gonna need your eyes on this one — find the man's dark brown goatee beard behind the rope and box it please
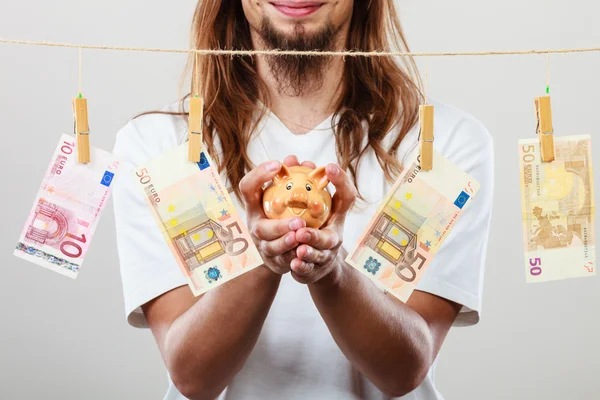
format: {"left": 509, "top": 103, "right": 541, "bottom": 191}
{"left": 261, "top": 18, "right": 335, "bottom": 96}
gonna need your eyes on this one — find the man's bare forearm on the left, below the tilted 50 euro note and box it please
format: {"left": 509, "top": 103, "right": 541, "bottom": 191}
{"left": 165, "top": 266, "right": 281, "bottom": 400}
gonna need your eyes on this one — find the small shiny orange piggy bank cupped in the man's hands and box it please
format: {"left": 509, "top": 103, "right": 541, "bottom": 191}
{"left": 263, "top": 165, "right": 331, "bottom": 229}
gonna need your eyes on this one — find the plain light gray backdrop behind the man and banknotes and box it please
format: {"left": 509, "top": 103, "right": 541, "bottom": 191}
{"left": 0, "top": 0, "right": 600, "bottom": 400}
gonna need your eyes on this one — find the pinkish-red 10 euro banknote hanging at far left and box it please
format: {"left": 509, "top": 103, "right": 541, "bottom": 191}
{"left": 13, "top": 134, "right": 119, "bottom": 278}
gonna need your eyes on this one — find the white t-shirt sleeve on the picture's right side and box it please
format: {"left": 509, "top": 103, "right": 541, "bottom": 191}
{"left": 417, "top": 116, "right": 494, "bottom": 326}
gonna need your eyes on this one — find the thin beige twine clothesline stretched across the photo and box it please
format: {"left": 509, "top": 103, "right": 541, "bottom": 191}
{"left": 0, "top": 39, "right": 600, "bottom": 57}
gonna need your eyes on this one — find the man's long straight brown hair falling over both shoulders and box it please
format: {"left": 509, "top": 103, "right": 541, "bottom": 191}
{"left": 162, "top": 0, "right": 422, "bottom": 198}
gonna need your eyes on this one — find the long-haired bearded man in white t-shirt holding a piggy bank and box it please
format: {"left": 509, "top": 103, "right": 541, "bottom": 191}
{"left": 114, "top": 0, "right": 493, "bottom": 400}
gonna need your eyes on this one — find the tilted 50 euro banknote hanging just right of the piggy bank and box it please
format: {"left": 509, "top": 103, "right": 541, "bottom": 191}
{"left": 346, "top": 152, "right": 480, "bottom": 302}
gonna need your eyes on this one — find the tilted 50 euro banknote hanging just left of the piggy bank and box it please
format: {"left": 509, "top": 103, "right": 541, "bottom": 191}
{"left": 132, "top": 143, "right": 263, "bottom": 296}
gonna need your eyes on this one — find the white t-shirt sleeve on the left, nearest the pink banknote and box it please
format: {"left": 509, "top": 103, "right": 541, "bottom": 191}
{"left": 113, "top": 117, "right": 186, "bottom": 328}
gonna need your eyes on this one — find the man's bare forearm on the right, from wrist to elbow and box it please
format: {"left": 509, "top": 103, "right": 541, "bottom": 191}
{"left": 309, "top": 252, "right": 435, "bottom": 397}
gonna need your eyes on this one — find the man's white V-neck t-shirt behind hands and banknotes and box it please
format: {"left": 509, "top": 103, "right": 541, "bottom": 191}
{"left": 113, "top": 97, "right": 494, "bottom": 400}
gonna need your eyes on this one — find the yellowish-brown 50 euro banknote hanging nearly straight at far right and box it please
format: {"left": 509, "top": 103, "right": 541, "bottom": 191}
{"left": 519, "top": 135, "right": 596, "bottom": 283}
